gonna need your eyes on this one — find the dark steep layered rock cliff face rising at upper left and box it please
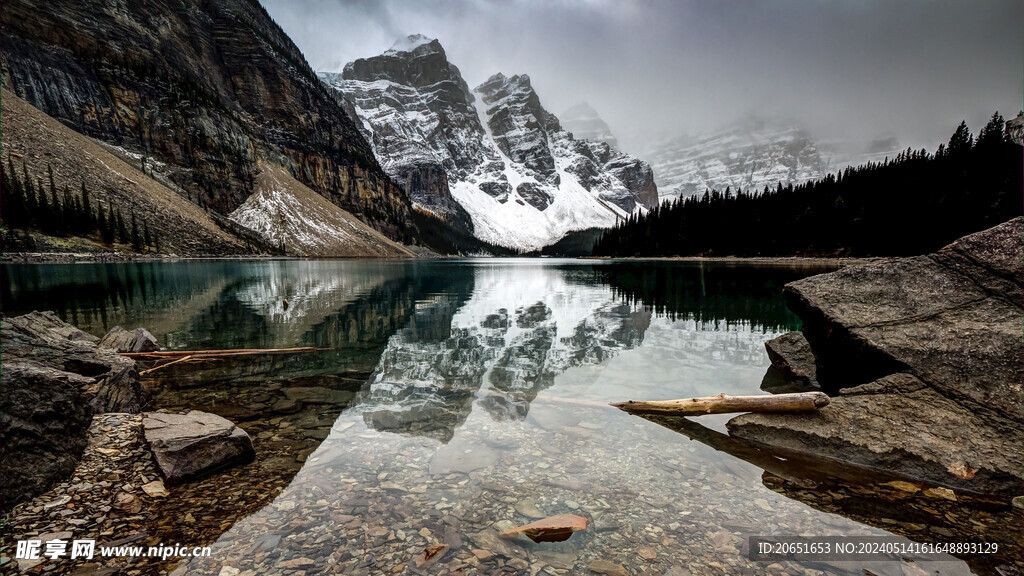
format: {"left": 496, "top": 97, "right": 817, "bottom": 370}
{"left": 0, "top": 0, "right": 409, "bottom": 237}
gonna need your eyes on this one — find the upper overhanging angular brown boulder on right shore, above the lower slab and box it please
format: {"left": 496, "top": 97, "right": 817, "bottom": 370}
{"left": 783, "top": 218, "right": 1024, "bottom": 412}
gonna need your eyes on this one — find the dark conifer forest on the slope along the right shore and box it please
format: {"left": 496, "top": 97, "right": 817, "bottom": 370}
{"left": 593, "top": 113, "right": 1024, "bottom": 256}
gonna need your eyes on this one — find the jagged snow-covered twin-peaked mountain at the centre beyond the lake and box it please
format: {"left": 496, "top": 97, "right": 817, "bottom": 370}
{"left": 321, "top": 35, "right": 657, "bottom": 249}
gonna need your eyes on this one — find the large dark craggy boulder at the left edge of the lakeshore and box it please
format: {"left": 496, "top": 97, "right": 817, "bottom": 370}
{"left": 0, "top": 312, "right": 144, "bottom": 505}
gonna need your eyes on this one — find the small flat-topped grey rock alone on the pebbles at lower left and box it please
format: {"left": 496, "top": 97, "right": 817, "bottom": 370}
{"left": 142, "top": 410, "right": 255, "bottom": 485}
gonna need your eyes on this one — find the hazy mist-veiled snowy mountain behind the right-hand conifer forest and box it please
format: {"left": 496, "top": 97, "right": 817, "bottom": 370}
{"left": 644, "top": 119, "right": 899, "bottom": 200}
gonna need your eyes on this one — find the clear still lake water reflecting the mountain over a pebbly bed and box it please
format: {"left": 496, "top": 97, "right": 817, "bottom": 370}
{"left": 2, "top": 259, "right": 1021, "bottom": 576}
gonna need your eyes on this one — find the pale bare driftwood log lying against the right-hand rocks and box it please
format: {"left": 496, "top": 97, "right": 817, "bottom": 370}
{"left": 612, "top": 392, "right": 828, "bottom": 416}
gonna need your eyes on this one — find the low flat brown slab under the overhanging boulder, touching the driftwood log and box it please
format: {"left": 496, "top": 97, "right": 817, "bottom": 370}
{"left": 727, "top": 374, "right": 1024, "bottom": 494}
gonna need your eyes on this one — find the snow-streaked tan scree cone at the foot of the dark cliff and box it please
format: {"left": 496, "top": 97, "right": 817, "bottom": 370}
{"left": 228, "top": 162, "right": 412, "bottom": 257}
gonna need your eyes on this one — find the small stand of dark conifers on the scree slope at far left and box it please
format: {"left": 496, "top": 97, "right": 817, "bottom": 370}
{"left": 0, "top": 156, "right": 160, "bottom": 252}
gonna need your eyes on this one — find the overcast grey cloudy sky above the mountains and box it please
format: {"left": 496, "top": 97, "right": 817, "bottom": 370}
{"left": 261, "top": 0, "right": 1024, "bottom": 151}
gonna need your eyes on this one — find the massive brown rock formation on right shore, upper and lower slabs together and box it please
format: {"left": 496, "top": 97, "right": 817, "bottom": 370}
{"left": 728, "top": 218, "right": 1024, "bottom": 494}
